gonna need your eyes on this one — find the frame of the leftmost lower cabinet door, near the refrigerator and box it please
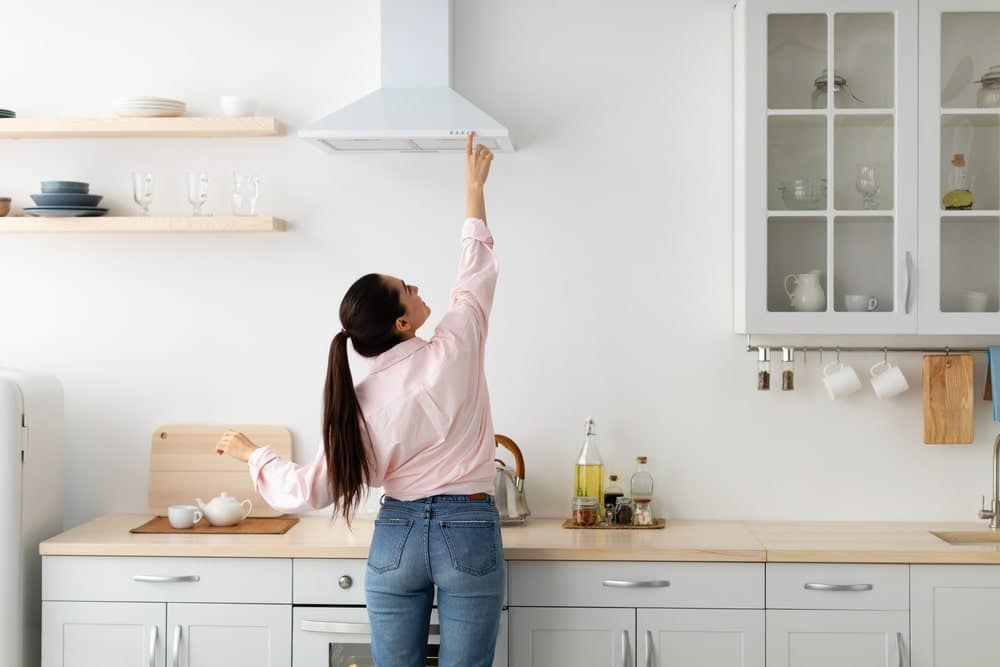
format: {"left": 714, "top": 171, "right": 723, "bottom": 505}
{"left": 41, "top": 601, "right": 167, "bottom": 667}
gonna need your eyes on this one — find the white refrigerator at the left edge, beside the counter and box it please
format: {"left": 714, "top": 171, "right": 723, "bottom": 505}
{"left": 0, "top": 369, "right": 63, "bottom": 667}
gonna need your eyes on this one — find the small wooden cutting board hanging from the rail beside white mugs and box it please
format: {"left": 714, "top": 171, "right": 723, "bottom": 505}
{"left": 923, "top": 354, "right": 973, "bottom": 445}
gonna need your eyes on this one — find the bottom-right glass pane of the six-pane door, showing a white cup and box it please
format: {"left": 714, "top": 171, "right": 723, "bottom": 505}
{"left": 833, "top": 217, "right": 896, "bottom": 312}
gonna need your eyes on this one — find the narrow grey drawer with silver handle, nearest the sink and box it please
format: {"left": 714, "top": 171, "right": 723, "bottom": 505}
{"left": 767, "top": 563, "right": 910, "bottom": 609}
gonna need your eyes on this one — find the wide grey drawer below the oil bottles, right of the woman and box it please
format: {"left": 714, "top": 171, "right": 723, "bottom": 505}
{"left": 509, "top": 561, "right": 764, "bottom": 609}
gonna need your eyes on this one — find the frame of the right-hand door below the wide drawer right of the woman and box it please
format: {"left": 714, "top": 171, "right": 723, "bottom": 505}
{"left": 635, "top": 609, "right": 765, "bottom": 667}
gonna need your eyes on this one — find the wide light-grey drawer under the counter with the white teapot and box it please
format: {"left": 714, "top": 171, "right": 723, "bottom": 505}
{"left": 42, "top": 556, "right": 292, "bottom": 604}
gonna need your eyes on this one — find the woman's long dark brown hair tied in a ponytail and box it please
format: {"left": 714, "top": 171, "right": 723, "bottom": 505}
{"left": 323, "top": 273, "right": 406, "bottom": 524}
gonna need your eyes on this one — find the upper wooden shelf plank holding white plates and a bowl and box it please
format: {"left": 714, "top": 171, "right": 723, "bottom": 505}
{"left": 0, "top": 116, "right": 285, "bottom": 139}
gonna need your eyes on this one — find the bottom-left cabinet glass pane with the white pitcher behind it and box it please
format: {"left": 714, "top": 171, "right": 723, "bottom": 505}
{"left": 767, "top": 218, "right": 826, "bottom": 312}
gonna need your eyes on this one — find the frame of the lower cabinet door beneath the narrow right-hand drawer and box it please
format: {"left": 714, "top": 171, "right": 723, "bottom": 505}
{"left": 766, "top": 609, "right": 910, "bottom": 667}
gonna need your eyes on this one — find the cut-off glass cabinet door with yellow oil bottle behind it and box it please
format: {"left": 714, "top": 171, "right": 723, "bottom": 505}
{"left": 920, "top": 0, "right": 1000, "bottom": 334}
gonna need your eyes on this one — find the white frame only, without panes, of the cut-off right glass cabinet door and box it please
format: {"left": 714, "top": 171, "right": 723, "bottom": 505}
{"left": 919, "top": 0, "right": 1000, "bottom": 335}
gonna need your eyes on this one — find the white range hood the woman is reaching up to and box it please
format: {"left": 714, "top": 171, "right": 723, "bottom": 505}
{"left": 298, "top": 0, "right": 514, "bottom": 153}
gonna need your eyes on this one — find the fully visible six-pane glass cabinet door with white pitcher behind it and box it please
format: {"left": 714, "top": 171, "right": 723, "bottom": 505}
{"left": 737, "top": 0, "right": 917, "bottom": 333}
